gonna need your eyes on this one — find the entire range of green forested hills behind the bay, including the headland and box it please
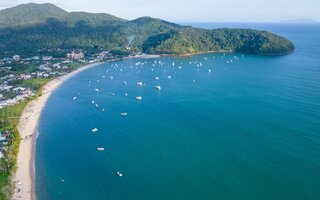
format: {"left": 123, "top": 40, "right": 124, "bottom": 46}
{"left": 0, "top": 4, "right": 294, "bottom": 56}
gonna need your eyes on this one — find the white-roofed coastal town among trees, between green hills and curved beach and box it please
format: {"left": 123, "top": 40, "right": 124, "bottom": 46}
{"left": 0, "top": 51, "right": 119, "bottom": 109}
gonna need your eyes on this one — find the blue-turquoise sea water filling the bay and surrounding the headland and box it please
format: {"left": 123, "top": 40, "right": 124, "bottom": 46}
{"left": 36, "top": 24, "right": 320, "bottom": 200}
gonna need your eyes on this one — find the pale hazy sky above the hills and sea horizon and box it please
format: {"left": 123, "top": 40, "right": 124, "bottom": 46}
{"left": 0, "top": 0, "right": 320, "bottom": 22}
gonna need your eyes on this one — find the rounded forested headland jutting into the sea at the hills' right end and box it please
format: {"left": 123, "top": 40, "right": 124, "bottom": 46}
{"left": 142, "top": 28, "right": 293, "bottom": 55}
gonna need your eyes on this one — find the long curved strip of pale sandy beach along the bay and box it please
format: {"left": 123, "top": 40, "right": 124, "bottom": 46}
{"left": 12, "top": 63, "right": 101, "bottom": 200}
